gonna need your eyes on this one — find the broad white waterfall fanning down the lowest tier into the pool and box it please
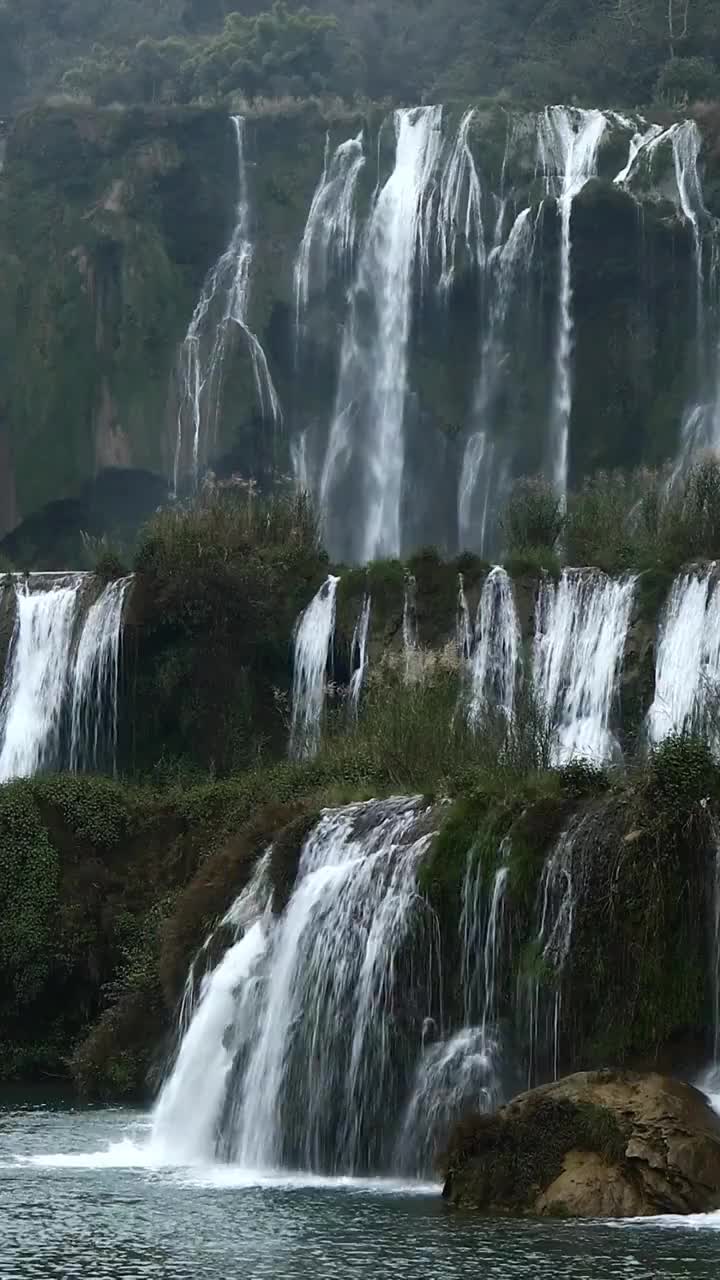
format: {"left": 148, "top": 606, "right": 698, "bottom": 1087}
{"left": 152, "top": 800, "right": 438, "bottom": 1172}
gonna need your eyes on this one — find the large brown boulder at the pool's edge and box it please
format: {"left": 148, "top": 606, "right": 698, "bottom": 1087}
{"left": 443, "top": 1071, "right": 720, "bottom": 1217}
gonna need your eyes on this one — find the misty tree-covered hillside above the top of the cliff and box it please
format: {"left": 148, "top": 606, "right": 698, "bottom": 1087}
{"left": 0, "top": 0, "right": 720, "bottom": 111}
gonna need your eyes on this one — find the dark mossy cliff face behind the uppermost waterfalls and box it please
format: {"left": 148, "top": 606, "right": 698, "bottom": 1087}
{"left": 0, "top": 104, "right": 717, "bottom": 558}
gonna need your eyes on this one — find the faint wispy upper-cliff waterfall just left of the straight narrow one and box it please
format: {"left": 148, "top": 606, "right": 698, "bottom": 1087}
{"left": 457, "top": 209, "right": 534, "bottom": 554}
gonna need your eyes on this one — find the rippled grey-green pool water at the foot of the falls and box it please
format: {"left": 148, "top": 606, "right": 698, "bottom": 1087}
{"left": 0, "top": 1102, "right": 720, "bottom": 1280}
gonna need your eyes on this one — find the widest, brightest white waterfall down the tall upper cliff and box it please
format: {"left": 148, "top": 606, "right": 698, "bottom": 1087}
{"left": 320, "top": 106, "right": 442, "bottom": 563}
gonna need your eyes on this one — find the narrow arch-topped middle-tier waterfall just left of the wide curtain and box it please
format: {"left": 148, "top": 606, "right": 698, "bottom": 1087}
{"left": 468, "top": 566, "right": 521, "bottom": 727}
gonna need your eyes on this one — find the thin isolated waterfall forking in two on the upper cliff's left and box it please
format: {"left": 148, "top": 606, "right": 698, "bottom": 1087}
{"left": 173, "top": 115, "right": 281, "bottom": 494}
